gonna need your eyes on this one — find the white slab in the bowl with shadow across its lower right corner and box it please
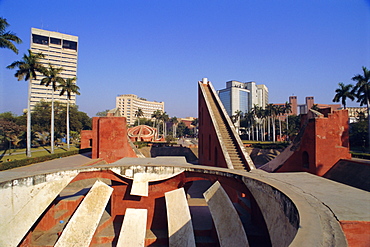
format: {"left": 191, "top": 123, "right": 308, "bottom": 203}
{"left": 165, "top": 188, "right": 195, "bottom": 247}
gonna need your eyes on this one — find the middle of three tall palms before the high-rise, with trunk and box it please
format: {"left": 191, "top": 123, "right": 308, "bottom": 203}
{"left": 40, "top": 63, "right": 64, "bottom": 154}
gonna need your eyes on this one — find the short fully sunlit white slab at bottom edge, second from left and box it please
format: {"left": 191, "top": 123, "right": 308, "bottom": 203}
{"left": 117, "top": 208, "right": 148, "bottom": 247}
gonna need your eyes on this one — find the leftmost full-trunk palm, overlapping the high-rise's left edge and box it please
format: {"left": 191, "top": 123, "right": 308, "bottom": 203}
{"left": 7, "top": 50, "right": 45, "bottom": 157}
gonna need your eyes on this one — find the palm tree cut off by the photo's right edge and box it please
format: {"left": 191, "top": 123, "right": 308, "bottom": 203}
{"left": 352, "top": 66, "right": 370, "bottom": 151}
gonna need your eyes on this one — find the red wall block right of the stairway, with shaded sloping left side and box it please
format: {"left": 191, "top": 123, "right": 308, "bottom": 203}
{"left": 278, "top": 110, "right": 351, "bottom": 176}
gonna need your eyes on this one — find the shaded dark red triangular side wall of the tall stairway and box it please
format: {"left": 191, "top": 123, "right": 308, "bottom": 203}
{"left": 198, "top": 84, "right": 227, "bottom": 168}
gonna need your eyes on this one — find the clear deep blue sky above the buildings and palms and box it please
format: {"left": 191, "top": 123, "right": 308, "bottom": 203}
{"left": 0, "top": 0, "right": 370, "bottom": 117}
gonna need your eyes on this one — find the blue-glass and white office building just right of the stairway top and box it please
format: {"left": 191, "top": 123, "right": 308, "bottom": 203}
{"left": 218, "top": 81, "right": 269, "bottom": 116}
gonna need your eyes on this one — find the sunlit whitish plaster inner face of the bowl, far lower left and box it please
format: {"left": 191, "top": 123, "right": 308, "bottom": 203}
{"left": 0, "top": 176, "right": 74, "bottom": 246}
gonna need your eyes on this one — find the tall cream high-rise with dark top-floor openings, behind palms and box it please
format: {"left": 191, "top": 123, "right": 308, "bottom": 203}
{"left": 31, "top": 28, "right": 78, "bottom": 109}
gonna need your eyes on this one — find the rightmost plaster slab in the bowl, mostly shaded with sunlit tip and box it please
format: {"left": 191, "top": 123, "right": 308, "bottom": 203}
{"left": 203, "top": 181, "right": 249, "bottom": 247}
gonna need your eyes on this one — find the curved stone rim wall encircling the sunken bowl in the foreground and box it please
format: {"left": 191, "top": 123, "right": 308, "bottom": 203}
{"left": 0, "top": 162, "right": 346, "bottom": 247}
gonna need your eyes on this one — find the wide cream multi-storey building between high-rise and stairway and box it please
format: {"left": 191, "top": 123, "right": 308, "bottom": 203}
{"left": 116, "top": 94, "right": 164, "bottom": 125}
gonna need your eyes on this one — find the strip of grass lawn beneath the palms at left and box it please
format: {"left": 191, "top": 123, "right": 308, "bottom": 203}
{"left": 0, "top": 145, "right": 79, "bottom": 162}
